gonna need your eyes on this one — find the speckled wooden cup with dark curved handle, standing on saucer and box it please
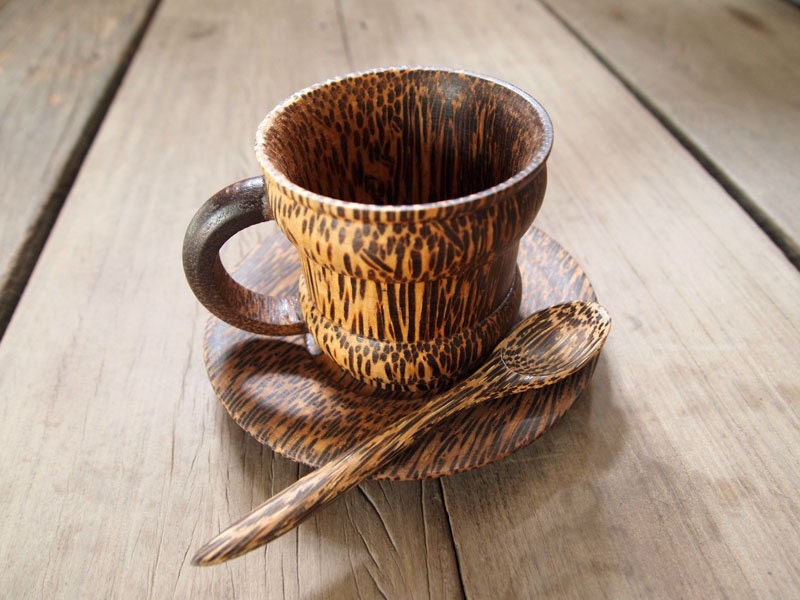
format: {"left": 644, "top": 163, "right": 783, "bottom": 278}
{"left": 183, "top": 68, "right": 553, "bottom": 393}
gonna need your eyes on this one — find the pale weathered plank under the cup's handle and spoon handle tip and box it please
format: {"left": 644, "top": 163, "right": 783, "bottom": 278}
{"left": 0, "top": 0, "right": 461, "bottom": 598}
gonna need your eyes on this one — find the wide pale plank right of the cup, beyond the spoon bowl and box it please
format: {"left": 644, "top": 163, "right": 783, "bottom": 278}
{"left": 334, "top": 1, "right": 800, "bottom": 598}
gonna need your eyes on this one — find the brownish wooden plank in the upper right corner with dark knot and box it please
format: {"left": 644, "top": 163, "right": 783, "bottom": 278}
{"left": 544, "top": 0, "right": 800, "bottom": 267}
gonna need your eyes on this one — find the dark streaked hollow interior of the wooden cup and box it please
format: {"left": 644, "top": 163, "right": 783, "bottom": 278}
{"left": 259, "top": 69, "right": 550, "bottom": 206}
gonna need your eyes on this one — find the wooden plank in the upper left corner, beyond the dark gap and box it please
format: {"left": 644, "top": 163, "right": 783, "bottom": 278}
{"left": 0, "top": 0, "right": 157, "bottom": 336}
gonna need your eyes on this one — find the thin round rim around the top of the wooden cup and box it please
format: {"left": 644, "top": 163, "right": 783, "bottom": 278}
{"left": 255, "top": 66, "right": 553, "bottom": 220}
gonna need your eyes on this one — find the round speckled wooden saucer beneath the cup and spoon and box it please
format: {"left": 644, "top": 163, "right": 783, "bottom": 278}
{"left": 204, "top": 228, "right": 597, "bottom": 480}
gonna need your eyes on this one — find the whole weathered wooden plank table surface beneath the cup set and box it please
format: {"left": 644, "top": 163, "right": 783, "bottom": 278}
{"left": 0, "top": 0, "right": 800, "bottom": 598}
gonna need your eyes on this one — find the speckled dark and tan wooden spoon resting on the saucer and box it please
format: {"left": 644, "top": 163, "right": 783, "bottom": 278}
{"left": 192, "top": 302, "right": 611, "bottom": 565}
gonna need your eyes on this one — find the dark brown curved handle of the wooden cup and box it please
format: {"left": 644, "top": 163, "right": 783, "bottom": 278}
{"left": 183, "top": 177, "right": 307, "bottom": 335}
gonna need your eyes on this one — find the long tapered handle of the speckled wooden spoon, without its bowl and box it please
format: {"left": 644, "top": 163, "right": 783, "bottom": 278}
{"left": 192, "top": 376, "right": 492, "bottom": 566}
